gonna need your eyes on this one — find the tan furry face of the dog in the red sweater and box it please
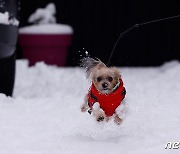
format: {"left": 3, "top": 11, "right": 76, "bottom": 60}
{"left": 91, "top": 66, "right": 120, "bottom": 94}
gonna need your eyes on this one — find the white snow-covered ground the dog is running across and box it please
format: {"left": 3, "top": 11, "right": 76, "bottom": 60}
{"left": 0, "top": 60, "right": 180, "bottom": 154}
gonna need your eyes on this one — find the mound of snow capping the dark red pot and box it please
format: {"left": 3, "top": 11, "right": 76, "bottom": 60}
{"left": 19, "top": 3, "right": 73, "bottom": 35}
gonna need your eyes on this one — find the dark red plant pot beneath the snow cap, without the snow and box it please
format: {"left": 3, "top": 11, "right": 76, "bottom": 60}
{"left": 18, "top": 34, "right": 72, "bottom": 66}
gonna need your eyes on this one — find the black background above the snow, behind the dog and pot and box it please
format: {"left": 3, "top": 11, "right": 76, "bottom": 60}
{"left": 18, "top": 0, "right": 180, "bottom": 66}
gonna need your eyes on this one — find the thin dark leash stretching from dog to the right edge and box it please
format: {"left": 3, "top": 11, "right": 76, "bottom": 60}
{"left": 107, "top": 15, "right": 180, "bottom": 66}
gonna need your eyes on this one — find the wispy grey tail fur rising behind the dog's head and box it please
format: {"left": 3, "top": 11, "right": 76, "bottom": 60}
{"left": 80, "top": 57, "right": 106, "bottom": 78}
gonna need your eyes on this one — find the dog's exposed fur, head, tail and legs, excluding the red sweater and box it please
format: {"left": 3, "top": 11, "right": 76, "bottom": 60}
{"left": 81, "top": 57, "right": 122, "bottom": 124}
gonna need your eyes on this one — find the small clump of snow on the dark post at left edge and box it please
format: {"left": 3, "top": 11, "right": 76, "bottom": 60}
{"left": 0, "top": 12, "right": 19, "bottom": 26}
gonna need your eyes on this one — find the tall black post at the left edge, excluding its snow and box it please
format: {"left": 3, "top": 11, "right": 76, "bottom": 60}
{"left": 0, "top": 0, "right": 18, "bottom": 96}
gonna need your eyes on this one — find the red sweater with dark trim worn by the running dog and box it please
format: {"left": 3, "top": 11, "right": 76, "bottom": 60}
{"left": 88, "top": 79, "right": 126, "bottom": 116}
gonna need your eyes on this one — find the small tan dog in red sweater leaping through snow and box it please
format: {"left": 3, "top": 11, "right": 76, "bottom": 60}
{"left": 81, "top": 57, "right": 126, "bottom": 124}
